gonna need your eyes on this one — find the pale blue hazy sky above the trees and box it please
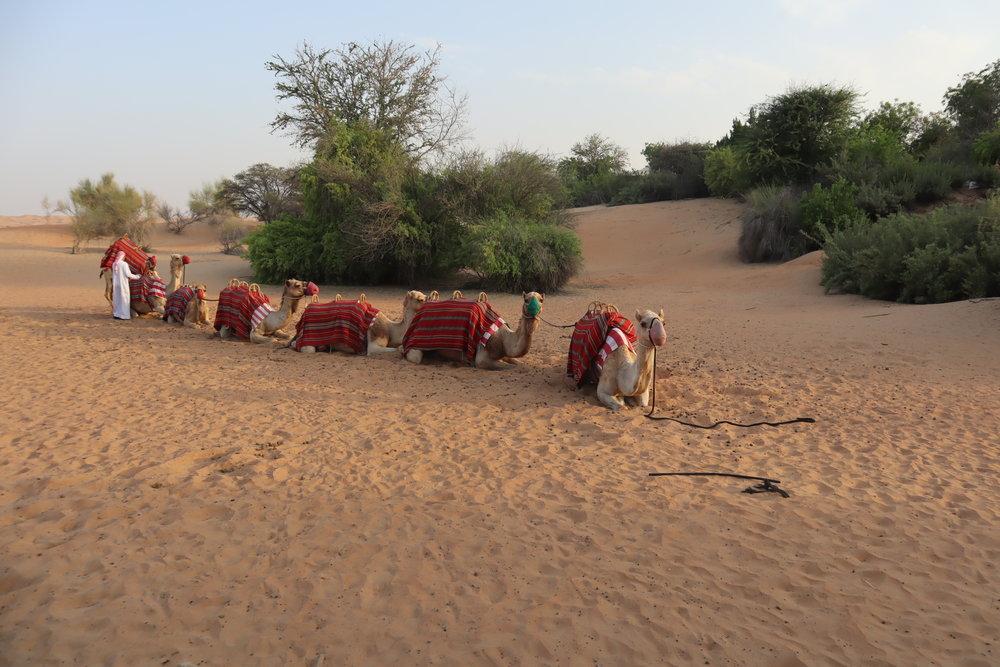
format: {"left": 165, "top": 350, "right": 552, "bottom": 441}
{"left": 0, "top": 0, "right": 1000, "bottom": 215}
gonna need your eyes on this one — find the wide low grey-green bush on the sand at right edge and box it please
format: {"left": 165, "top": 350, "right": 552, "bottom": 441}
{"left": 821, "top": 198, "right": 1000, "bottom": 303}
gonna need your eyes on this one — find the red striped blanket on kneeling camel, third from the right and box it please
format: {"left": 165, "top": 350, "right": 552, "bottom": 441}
{"left": 292, "top": 301, "right": 379, "bottom": 354}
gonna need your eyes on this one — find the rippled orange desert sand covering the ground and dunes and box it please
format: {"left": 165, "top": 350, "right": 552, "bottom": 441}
{"left": 0, "top": 204, "right": 1000, "bottom": 666}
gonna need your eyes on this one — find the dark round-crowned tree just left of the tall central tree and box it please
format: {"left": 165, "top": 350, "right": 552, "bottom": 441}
{"left": 217, "top": 163, "right": 302, "bottom": 223}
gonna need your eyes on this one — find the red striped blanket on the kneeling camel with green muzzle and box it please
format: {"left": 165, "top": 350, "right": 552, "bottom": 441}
{"left": 403, "top": 299, "right": 506, "bottom": 365}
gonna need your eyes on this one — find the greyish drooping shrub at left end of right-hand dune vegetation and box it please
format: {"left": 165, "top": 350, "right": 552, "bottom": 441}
{"left": 738, "top": 185, "right": 807, "bottom": 262}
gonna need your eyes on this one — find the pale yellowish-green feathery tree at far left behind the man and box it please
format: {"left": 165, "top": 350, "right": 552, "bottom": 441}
{"left": 56, "top": 173, "right": 157, "bottom": 252}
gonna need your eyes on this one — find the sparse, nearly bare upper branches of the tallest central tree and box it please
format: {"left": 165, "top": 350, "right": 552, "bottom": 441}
{"left": 266, "top": 41, "right": 466, "bottom": 158}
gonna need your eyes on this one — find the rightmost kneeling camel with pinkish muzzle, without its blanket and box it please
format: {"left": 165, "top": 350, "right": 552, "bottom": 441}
{"left": 594, "top": 308, "right": 667, "bottom": 410}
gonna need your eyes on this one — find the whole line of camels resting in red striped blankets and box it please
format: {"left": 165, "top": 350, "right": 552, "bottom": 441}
{"left": 100, "top": 236, "right": 666, "bottom": 410}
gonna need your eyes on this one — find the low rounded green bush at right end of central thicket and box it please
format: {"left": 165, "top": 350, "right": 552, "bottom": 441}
{"left": 468, "top": 213, "right": 582, "bottom": 292}
